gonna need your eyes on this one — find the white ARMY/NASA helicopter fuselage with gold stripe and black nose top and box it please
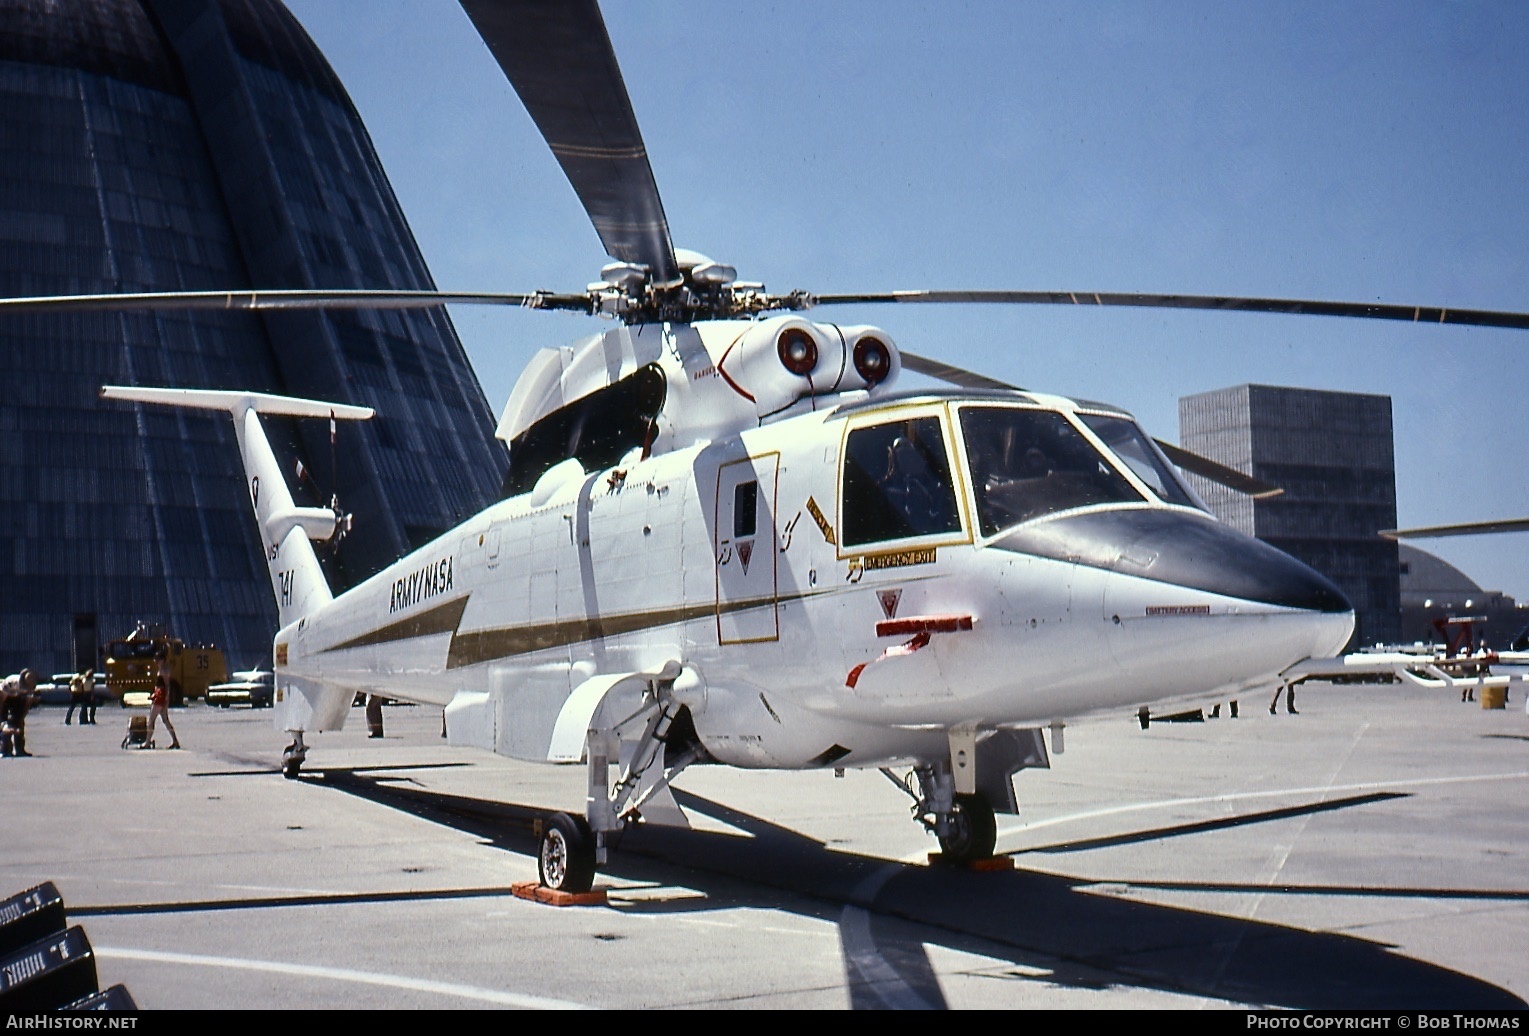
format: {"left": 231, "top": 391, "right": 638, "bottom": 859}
{"left": 277, "top": 394, "right": 1353, "bottom": 767}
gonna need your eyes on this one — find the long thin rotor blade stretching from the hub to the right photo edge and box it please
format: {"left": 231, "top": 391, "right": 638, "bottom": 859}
{"left": 813, "top": 290, "right": 1529, "bottom": 330}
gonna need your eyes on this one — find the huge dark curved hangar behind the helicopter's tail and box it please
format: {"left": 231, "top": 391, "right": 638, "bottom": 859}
{"left": 0, "top": 0, "right": 508, "bottom": 677}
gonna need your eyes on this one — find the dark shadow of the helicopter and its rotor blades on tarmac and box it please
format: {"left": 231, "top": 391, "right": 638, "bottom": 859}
{"left": 80, "top": 767, "right": 1529, "bottom": 1010}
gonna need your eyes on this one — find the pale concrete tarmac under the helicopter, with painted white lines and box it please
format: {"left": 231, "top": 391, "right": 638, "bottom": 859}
{"left": 0, "top": 685, "right": 1529, "bottom": 1012}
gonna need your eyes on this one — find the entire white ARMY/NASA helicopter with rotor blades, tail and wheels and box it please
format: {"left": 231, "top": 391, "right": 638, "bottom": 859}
{"left": 17, "top": 0, "right": 1529, "bottom": 892}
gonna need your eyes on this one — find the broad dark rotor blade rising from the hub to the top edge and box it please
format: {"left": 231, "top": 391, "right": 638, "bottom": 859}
{"left": 462, "top": 0, "right": 680, "bottom": 287}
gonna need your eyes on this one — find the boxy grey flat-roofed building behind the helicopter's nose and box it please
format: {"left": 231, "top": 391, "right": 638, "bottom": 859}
{"left": 1179, "top": 385, "right": 1401, "bottom": 645}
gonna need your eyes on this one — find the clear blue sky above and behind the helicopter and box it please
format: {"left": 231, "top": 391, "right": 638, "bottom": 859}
{"left": 287, "top": 0, "right": 1529, "bottom": 601}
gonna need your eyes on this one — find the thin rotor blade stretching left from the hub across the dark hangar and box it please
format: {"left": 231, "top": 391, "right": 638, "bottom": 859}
{"left": 0, "top": 289, "right": 590, "bottom": 316}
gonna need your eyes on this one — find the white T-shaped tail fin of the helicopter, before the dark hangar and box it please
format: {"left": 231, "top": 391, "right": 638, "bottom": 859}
{"left": 101, "top": 385, "right": 373, "bottom": 628}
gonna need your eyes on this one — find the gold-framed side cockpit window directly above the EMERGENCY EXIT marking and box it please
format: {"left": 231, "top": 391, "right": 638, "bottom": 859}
{"left": 842, "top": 417, "right": 960, "bottom": 547}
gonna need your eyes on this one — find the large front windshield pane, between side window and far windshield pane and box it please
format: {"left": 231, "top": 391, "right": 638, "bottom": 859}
{"left": 960, "top": 406, "right": 1142, "bottom": 536}
